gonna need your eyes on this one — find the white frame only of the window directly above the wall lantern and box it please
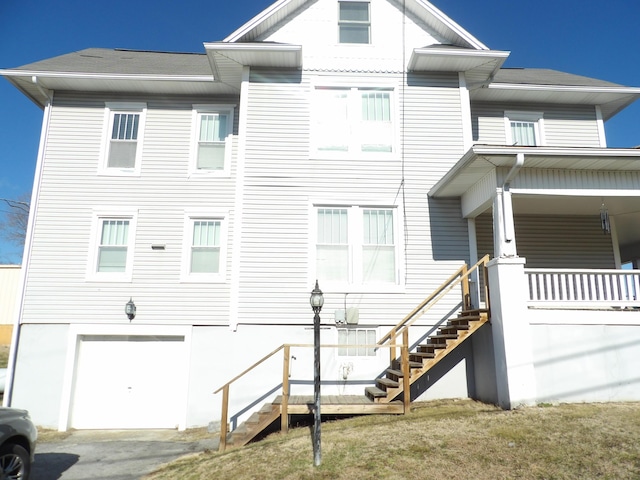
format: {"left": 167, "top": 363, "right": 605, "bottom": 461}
{"left": 87, "top": 209, "right": 138, "bottom": 282}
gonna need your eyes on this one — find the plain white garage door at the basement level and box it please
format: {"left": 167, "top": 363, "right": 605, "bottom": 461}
{"left": 70, "top": 335, "right": 187, "bottom": 429}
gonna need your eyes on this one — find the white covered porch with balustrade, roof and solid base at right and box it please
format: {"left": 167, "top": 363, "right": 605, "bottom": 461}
{"left": 429, "top": 145, "right": 640, "bottom": 408}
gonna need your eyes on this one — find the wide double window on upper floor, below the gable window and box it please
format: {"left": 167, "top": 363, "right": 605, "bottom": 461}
{"left": 314, "top": 87, "right": 395, "bottom": 154}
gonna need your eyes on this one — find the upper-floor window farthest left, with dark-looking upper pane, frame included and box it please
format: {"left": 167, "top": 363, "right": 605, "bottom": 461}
{"left": 101, "top": 103, "right": 146, "bottom": 175}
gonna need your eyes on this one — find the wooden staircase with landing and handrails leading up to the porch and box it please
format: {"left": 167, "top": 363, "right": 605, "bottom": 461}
{"left": 214, "top": 256, "right": 490, "bottom": 451}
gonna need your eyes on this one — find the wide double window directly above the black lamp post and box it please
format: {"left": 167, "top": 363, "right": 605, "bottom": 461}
{"left": 314, "top": 206, "right": 399, "bottom": 287}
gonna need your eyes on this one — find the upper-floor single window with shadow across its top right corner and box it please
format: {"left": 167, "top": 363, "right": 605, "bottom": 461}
{"left": 191, "top": 105, "right": 234, "bottom": 177}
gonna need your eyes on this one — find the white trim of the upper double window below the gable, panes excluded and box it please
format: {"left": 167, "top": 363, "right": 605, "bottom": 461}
{"left": 311, "top": 83, "right": 400, "bottom": 159}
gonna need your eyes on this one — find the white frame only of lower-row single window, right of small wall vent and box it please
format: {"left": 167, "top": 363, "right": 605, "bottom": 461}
{"left": 180, "top": 209, "right": 228, "bottom": 283}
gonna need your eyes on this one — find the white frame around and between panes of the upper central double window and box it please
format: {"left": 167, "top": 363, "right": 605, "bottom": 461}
{"left": 311, "top": 84, "right": 399, "bottom": 159}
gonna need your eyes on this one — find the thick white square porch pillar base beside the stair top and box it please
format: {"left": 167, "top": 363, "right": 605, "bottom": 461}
{"left": 487, "top": 258, "right": 536, "bottom": 409}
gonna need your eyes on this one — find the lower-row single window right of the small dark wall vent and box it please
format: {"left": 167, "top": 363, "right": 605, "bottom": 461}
{"left": 183, "top": 214, "right": 225, "bottom": 282}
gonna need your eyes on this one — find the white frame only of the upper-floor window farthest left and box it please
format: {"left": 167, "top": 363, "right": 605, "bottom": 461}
{"left": 98, "top": 102, "right": 147, "bottom": 176}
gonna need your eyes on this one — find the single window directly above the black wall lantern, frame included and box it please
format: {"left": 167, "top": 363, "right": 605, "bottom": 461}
{"left": 88, "top": 212, "right": 136, "bottom": 281}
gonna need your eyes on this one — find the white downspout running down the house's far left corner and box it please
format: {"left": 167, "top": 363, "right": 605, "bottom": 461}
{"left": 2, "top": 75, "right": 53, "bottom": 407}
